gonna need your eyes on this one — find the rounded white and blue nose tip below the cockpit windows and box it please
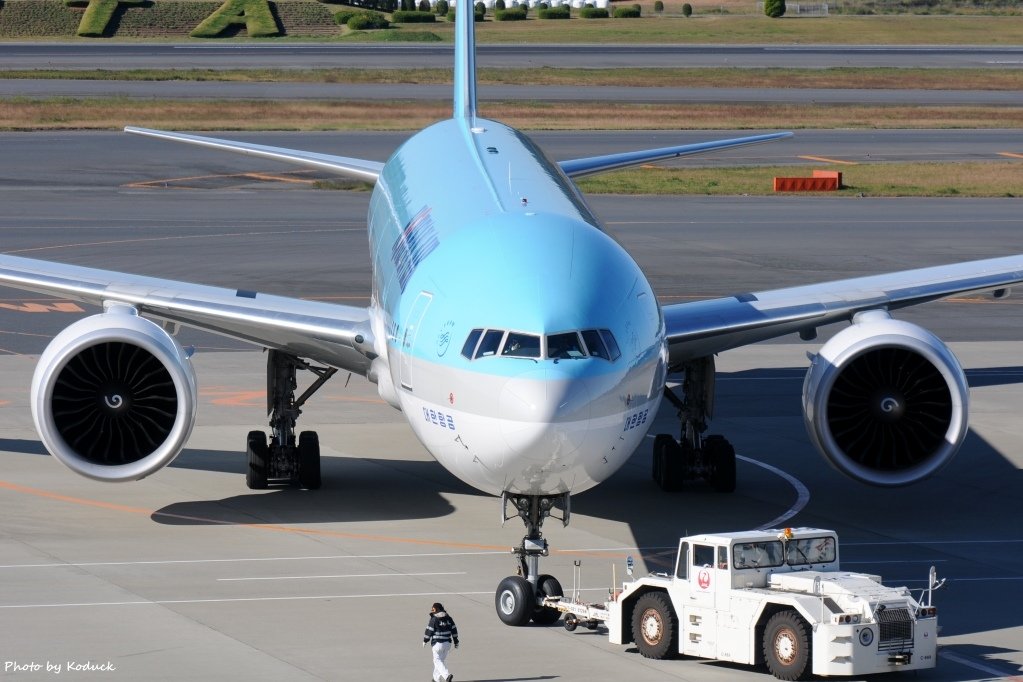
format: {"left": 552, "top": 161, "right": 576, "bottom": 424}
{"left": 498, "top": 367, "right": 590, "bottom": 461}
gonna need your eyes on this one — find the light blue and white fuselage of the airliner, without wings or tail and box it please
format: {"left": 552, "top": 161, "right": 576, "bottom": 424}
{"left": 369, "top": 118, "right": 666, "bottom": 495}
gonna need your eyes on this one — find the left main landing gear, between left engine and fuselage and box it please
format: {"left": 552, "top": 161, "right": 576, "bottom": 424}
{"left": 246, "top": 351, "right": 338, "bottom": 490}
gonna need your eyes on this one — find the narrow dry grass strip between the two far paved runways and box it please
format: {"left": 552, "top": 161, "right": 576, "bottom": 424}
{"left": 0, "top": 66, "right": 1023, "bottom": 91}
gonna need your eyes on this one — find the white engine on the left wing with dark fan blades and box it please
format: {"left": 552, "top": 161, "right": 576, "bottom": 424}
{"left": 32, "top": 306, "right": 197, "bottom": 481}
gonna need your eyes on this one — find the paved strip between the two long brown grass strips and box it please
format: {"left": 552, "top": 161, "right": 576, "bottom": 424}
{"left": 0, "top": 79, "right": 1023, "bottom": 106}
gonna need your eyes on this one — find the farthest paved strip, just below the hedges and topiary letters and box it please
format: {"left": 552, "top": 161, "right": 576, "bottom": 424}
{"left": 6, "top": 41, "right": 1023, "bottom": 69}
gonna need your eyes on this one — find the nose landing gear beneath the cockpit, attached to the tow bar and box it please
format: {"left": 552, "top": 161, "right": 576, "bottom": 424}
{"left": 494, "top": 493, "right": 571, "bottom": 626}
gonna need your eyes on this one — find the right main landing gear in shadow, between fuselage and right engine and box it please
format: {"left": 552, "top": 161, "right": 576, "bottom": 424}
{"left": 653, "top": 356, "right": 736, "bottom": 493}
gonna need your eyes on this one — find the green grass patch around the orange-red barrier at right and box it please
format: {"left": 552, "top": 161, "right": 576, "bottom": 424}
{"left": 578, "top": 160, "right": 1023, "bottom": 197}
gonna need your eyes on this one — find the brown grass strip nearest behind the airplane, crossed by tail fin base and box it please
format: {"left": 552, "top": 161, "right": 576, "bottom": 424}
{"left": 0, "top": 97, "right": 1023, "bottom": 131}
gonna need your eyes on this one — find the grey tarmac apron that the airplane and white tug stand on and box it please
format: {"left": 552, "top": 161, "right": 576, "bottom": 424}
{"left": 0, "top": 133, "right": 1023, "bottom": 682}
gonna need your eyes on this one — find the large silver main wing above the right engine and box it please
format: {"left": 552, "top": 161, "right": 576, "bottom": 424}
{"left": 664, "top": 256, "right": 1023, "bottom": 365}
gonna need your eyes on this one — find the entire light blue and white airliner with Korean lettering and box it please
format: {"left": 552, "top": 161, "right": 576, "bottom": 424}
{"left": 0, "top": 3, "right": 1023, "bottom": 626}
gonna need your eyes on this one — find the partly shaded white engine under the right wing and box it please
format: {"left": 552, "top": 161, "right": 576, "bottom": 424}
{"left": 803, "top": 311, "right": 970, "bottom": 486}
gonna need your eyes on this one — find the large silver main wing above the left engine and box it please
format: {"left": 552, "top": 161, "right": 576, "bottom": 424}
{"left": 0, "top": 255, "right": 372, "bottom": 374}
